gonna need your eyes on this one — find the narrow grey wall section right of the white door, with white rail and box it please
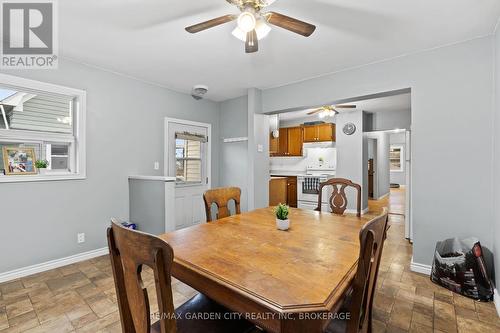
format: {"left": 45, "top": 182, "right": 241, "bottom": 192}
{"left": 219, "top": 96, "right": 249, "bottom": 211}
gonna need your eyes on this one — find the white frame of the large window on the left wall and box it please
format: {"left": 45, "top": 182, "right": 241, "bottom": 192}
{"left": 0, "top": 74, "right": 87, "bottom": 183}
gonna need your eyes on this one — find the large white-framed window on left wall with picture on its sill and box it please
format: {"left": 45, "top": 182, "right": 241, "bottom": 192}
{"left": 0, "top": 74, "right": 85, "bottom": 182}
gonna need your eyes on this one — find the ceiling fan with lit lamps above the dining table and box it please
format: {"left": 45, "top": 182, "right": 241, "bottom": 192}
{"left": 186, "top": 0, "right": 316, "bottom": 53}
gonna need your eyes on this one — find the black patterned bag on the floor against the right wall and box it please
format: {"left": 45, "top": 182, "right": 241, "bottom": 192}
{"left": 431, "top": 238, "right": 493, "bottom": 301}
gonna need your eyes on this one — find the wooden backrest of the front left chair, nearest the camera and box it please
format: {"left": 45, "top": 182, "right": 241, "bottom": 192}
{"left": 108, "top": 220, "right": 177, "bottom": 333}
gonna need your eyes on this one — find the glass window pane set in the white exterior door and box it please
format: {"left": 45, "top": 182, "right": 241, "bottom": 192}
{"left": 175, "top": 132, "right": 207, "bottom": 184}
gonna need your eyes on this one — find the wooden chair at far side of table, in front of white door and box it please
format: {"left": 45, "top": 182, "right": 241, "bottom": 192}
{"left": 203, "top": 187, "right": 241, "bottom": 222}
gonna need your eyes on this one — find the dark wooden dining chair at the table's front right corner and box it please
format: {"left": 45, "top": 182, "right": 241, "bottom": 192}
{"left": 325, "top": 208, "right": 388, "bottom": 333}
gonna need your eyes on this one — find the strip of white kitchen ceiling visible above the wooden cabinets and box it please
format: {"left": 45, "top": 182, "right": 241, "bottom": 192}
{"left": 279, "top": 93, "right": 411, "bottom": 121}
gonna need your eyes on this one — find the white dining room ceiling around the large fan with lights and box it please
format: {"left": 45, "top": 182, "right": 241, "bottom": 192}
{"left": 59, "top": 0, "right": 500, "bottom": 101}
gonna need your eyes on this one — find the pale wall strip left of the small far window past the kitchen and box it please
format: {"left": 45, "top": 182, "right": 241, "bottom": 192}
{"left": 365, "top": 132, "right": 390, "bottom": 198}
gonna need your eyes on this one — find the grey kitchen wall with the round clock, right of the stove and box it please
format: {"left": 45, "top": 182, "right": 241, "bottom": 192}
{"left": 336, "top": 111, "right": 368, "bottom": 210}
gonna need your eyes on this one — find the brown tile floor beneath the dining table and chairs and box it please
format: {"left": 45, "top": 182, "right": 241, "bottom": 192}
{"left": 0, "top": 189, "right": 500, "bottom": 333}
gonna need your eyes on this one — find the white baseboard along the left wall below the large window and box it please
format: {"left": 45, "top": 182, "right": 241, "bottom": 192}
{"left": 0, "top": 247, "right": 109, "bottom": 283}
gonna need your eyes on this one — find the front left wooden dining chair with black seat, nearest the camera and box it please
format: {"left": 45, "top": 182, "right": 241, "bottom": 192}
{"left": 107, "top": 220, "right": 255, "bottom": 333}
